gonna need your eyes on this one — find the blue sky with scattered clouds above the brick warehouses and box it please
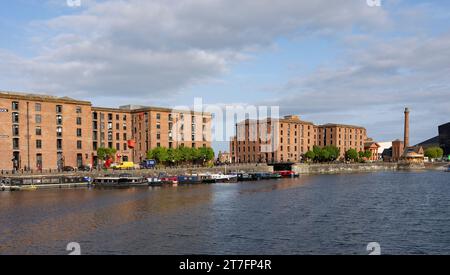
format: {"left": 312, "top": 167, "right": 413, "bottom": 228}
{"left": 0, "top": 0, "right": 450, "bottom": 153}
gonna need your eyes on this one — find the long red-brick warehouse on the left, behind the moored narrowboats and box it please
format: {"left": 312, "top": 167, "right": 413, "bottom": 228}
{"left": 0, "top": 91, "right": 211, "bottom": 170}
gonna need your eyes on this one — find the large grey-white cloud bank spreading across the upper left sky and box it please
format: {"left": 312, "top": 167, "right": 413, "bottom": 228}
{"left": 0, "top": 0, "right": 388, "bottom": 98}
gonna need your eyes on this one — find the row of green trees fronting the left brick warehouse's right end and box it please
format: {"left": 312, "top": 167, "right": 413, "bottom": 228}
{"left": 147, "top": 146, "right": 214, "bottom": 165}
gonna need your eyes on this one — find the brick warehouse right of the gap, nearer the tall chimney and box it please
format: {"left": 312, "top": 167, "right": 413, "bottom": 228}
{"left": 230, "top": 115, "right": 367, "bottom": 163}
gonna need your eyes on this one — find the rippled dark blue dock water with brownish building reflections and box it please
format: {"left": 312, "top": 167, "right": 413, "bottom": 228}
{"left": 0, "top": 172, "right": 450, "bottom": 254}
